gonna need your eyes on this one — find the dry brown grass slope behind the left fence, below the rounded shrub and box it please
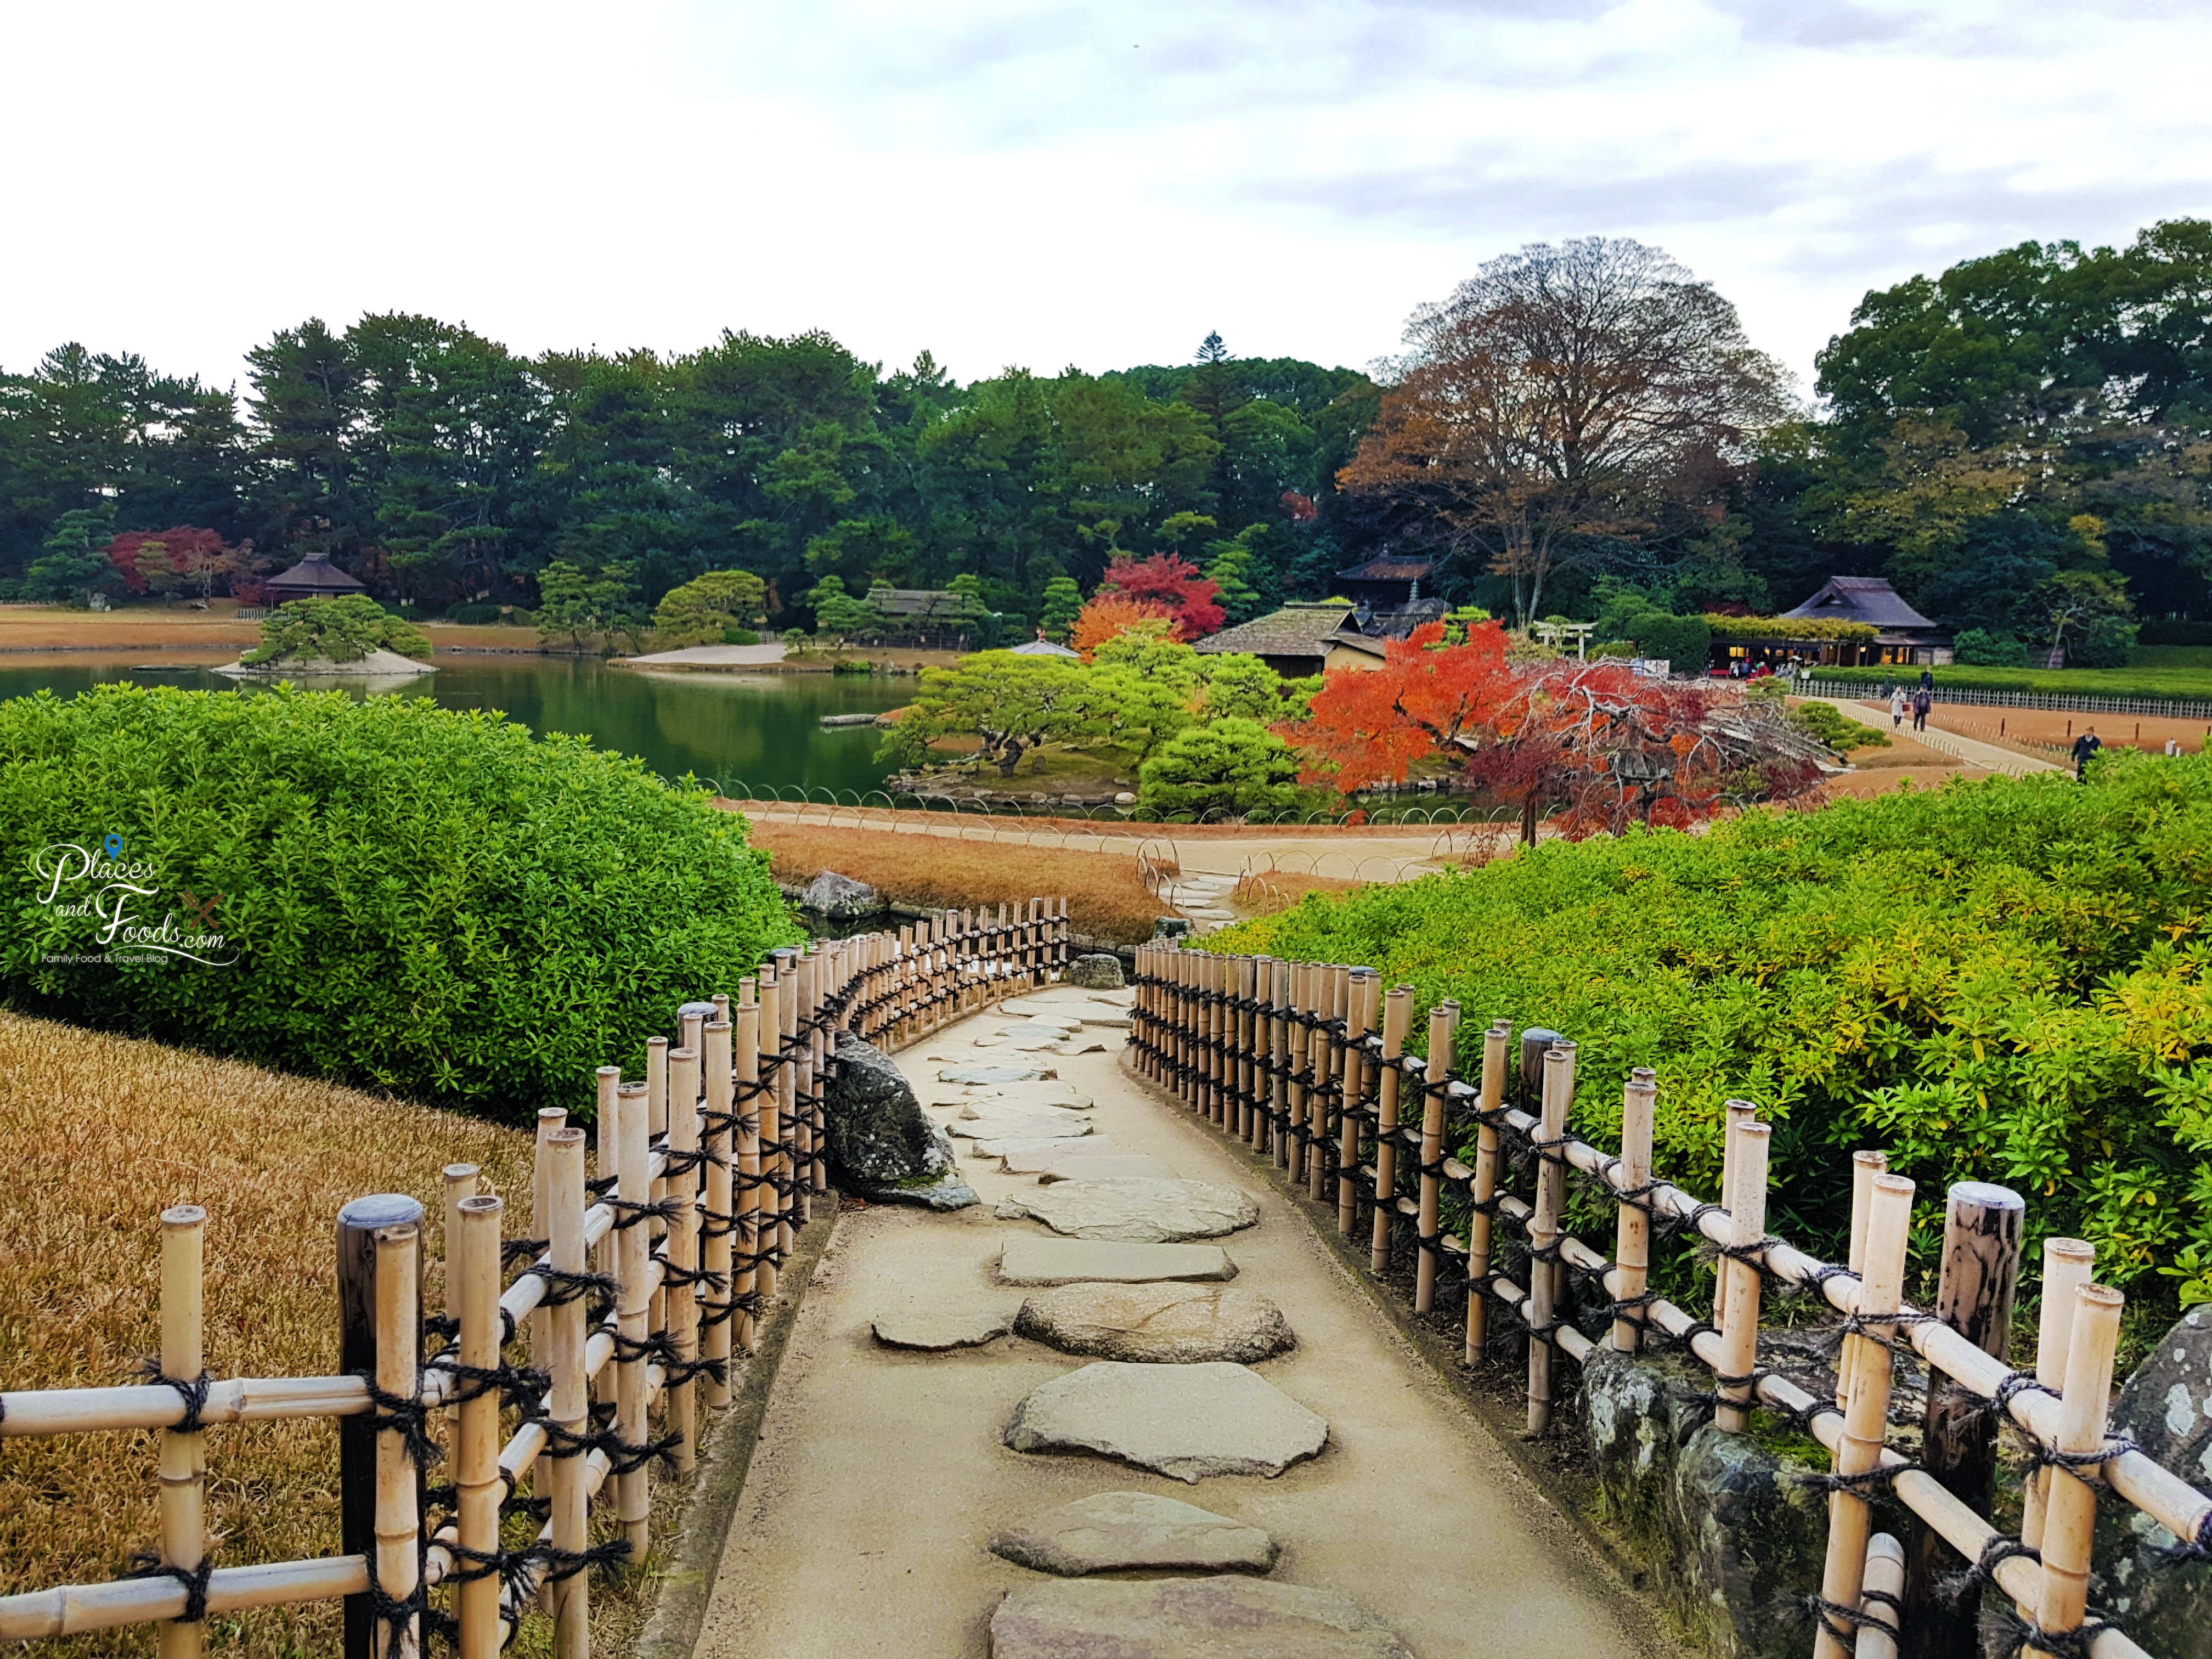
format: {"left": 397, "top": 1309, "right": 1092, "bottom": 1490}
{"left": 0, "top": 1013, "right": 553, "bottom": 1659}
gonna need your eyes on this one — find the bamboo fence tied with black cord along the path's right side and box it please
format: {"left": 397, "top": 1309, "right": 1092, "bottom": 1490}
{"left": 1130, "top": 943, "right": 2212, "bottom": 1659}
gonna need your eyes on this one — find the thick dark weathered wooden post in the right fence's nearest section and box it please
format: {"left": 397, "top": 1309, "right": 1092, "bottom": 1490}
{"left": 1903, "top": 1181, "right": 2028, "bottom": 1659}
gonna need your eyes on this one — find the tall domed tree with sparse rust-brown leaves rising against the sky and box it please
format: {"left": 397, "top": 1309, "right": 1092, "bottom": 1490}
{"left": 1338, "top": 236, "right": 1787, "bottom": 626}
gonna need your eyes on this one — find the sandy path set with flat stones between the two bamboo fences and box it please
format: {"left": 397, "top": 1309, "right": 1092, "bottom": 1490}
{"left": 697, "top": 989, "right": 1674, "bottom": 1659}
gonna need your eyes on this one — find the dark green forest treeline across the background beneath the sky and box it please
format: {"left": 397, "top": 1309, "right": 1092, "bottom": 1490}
{"left": 0, "top": 219, "right": 2212, "bottom": 639}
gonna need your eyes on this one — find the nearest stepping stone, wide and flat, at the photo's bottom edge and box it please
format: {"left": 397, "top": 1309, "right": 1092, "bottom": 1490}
{"left": 991, "top": 1575, "right": 1413, "bottom": 1659}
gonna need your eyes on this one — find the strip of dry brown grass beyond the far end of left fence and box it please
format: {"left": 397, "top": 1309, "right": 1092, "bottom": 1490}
{"left": 752, "top": 819, "right": 1161, "bottom": 943}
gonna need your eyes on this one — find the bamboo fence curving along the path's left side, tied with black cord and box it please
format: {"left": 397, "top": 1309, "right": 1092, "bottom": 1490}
{"left": 0, "top": 898, "right": 1068, "bottom": 1659}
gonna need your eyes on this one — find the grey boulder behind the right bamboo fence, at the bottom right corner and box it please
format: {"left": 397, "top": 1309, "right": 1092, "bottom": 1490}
{"left": 2097, "top": 1307, "right": 2212, "bottom": 1659}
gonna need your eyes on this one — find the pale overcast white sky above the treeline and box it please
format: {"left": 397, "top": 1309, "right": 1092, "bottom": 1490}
{"left": 0, "top": 0, "right": 2212, "bottom": 402}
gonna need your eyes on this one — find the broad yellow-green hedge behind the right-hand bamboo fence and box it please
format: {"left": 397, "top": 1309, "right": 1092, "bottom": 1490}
{"left": 1207, "top": 750, "right": 2212, "bottom": 1301}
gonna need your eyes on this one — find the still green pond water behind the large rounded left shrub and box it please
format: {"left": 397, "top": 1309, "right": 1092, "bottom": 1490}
{"left": 0, "top": 654, "right": 916, "bottom": 789}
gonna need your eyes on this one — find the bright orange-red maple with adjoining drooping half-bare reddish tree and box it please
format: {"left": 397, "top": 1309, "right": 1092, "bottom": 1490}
{"left": 1276, "top": 622, "right": 1818, "bottom": 840}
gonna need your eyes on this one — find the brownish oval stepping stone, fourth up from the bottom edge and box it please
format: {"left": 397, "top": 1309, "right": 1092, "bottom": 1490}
{"left": 1013, "top": 1285, "right": 1299, "bottom": 1365}
